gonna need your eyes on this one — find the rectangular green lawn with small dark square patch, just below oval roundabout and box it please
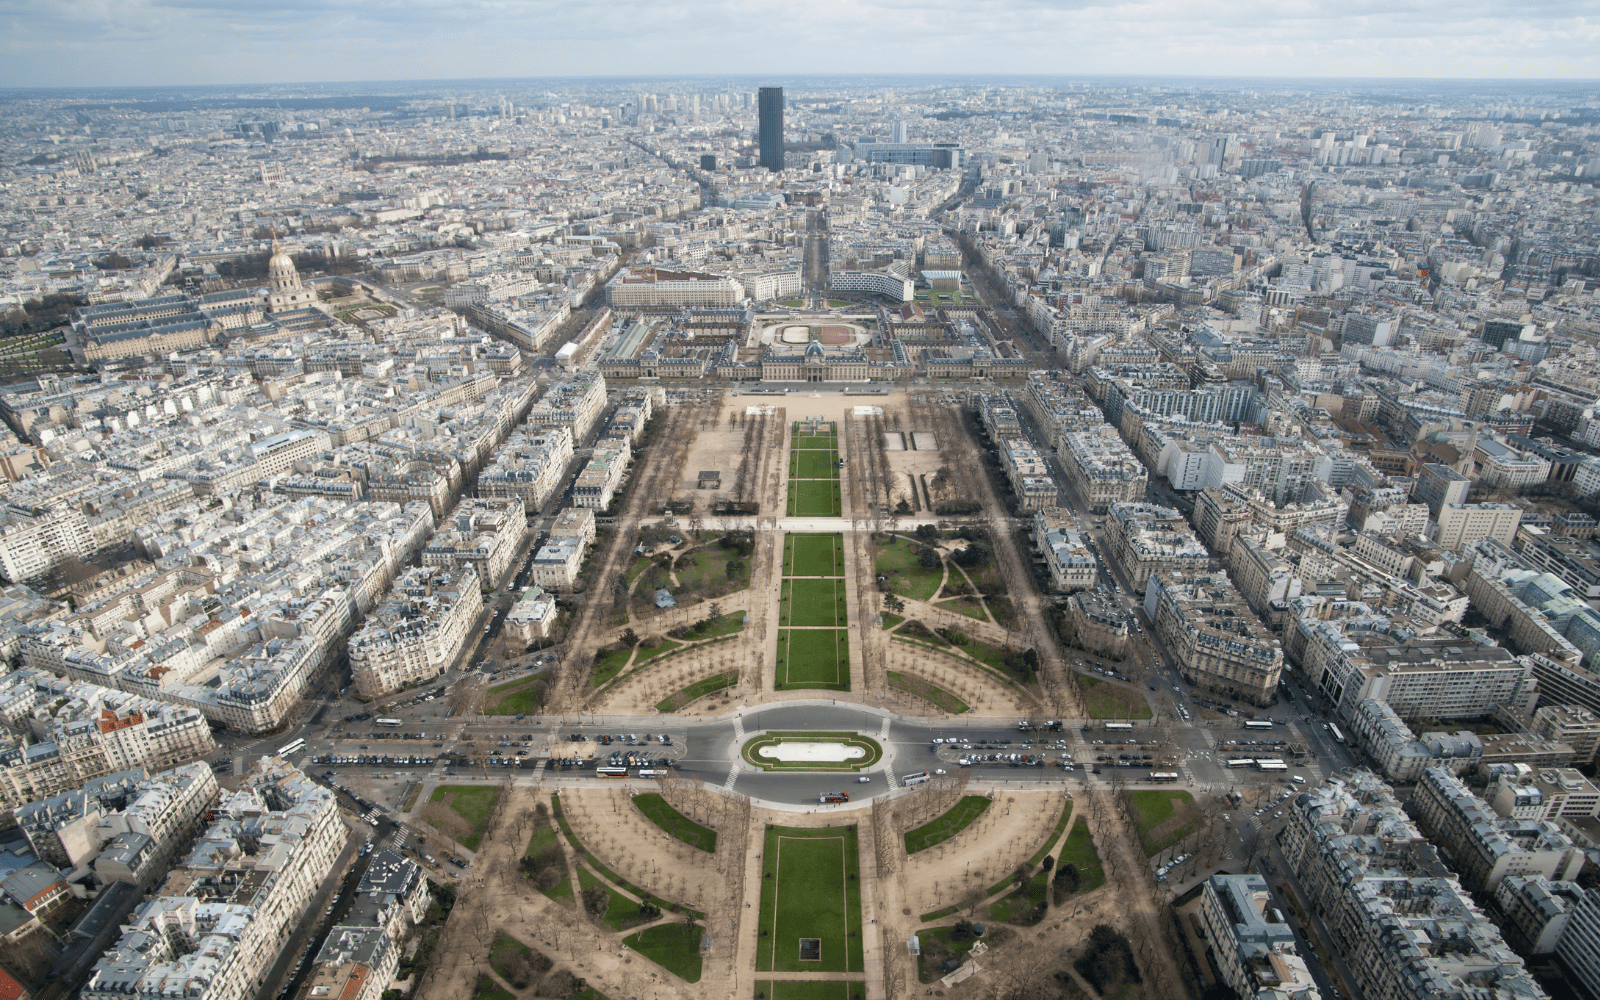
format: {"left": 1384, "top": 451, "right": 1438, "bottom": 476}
{"left": 755, "top": 826, "right": 866, "bottom": 973}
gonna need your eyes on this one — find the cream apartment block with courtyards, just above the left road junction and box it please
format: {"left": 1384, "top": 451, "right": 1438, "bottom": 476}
{"left": 349, "top": 563, "right": 483, "bottom": 698}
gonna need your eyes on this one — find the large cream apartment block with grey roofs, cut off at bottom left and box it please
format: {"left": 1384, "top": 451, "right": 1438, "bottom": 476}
{"left": 80, "top": 757, "right": 347, "bottom": 1000}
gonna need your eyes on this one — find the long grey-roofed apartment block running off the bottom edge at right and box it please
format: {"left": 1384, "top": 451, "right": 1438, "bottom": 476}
{"left": 1280, "top": 771, "right": 1544, "bottom": 1000}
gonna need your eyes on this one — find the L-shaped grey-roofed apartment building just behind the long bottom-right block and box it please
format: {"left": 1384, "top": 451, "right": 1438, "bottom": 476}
{"left": 1411, "top": 766, "right": 1586, "bottom": 893}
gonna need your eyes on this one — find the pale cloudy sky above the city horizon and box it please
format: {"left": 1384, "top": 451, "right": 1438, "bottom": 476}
{"left": 0, "top": 0, "right": 1600, "bottom": 86}
